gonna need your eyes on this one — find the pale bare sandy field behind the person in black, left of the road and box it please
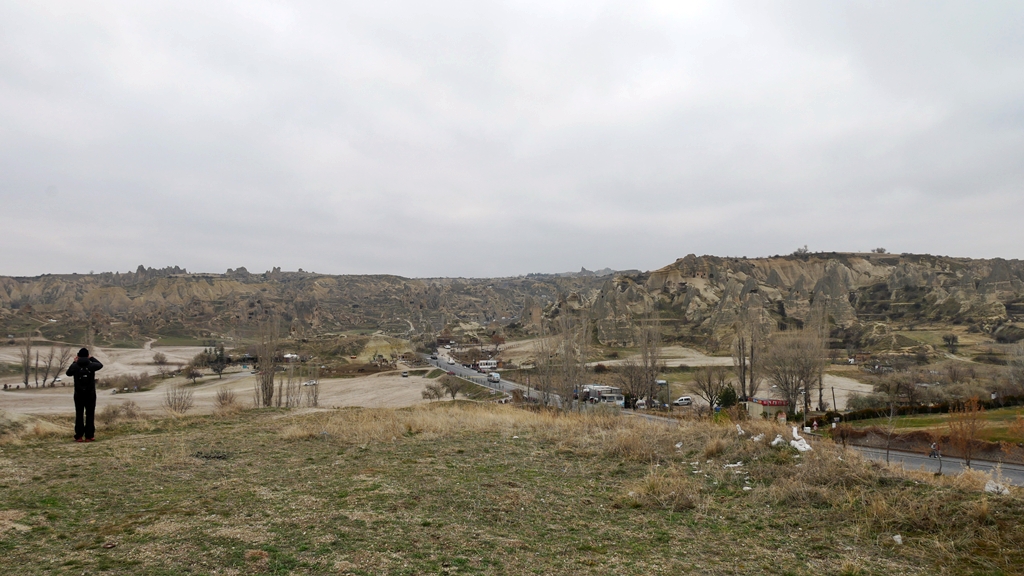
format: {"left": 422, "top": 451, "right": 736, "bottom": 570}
{"left": 0, "top": 364, "right": 430, "bottom": 415}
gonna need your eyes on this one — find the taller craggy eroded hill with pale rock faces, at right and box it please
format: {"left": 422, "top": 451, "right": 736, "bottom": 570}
{"left": 592, "top": 253, "right": 1024, "bottom": 343}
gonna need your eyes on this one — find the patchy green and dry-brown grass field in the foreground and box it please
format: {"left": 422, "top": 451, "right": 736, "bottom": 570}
{"left": 0, "top": 402, "right": 1024, "bottom": 575}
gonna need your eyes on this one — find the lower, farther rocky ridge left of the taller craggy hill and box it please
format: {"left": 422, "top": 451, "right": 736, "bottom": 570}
{"left": 0, "top": 266, "right": 603, "bottom": 346}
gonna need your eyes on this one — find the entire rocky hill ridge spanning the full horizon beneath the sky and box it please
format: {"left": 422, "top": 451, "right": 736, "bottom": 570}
{"left": 0, "top": 252, "right": 1024, "bottom": 344}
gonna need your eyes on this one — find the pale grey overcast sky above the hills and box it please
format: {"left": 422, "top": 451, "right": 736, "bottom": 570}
{"left": 0, "top": 0, "right": 1024, "bottom": 277}
